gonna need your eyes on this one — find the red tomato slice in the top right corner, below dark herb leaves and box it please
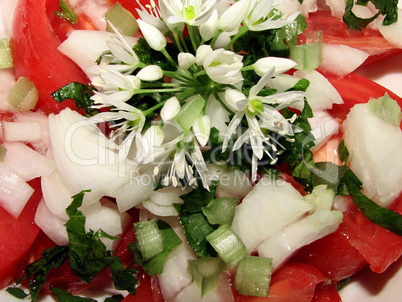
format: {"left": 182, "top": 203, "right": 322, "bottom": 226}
{"left": 300, "top": 10, "right": 402, "bottom": 64}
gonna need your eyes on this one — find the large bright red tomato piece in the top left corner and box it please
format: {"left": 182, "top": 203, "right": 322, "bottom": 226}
{"left": 11, "top": 0, "right": 88, "bottom": 114}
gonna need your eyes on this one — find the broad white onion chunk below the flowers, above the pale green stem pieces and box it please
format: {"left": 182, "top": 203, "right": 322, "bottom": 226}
{"left": 232, "top": 176, "right": 312, "bottom": 253}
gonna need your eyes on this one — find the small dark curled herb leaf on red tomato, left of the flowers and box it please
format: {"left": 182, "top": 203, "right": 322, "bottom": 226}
{"left": 52, "top": 82, "right": 96, "bottom": 115}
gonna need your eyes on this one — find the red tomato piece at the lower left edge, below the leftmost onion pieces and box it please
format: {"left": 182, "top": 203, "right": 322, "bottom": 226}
{"left": 0, "top": 178, "right": 42, "bottom": 288}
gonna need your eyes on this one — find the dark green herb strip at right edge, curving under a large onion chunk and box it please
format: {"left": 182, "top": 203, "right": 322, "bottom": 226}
{"left": 345, "top": 170, "right": 402, "bottom": 235}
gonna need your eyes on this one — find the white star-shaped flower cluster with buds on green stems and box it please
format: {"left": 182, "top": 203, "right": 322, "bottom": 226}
{"left": 90, "top": 0, "right": 304, "bottom": 188}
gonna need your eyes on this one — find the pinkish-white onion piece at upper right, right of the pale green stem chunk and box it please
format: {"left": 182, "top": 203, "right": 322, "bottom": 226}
{"left": 318, "top": 43, "right": 369, "bottom": 76}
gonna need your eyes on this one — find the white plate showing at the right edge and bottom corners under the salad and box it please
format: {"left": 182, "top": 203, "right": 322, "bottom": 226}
{"left": 0, "top": 54, "right": 402, "bottom": 302}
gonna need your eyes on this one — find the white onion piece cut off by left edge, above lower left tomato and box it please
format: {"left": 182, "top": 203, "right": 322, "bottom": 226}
{"left": 0, "top": 163, "right": 34, "bottom": 217}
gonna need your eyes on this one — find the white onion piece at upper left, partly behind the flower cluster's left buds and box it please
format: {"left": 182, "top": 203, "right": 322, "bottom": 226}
{"left": 58, "top": 30, "right": 137, "bottom": 72}
